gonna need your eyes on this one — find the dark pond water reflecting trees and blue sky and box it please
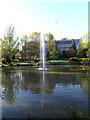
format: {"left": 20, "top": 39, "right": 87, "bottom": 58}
{"left": 2, "top": 65, "right": 90, "bottom": 118}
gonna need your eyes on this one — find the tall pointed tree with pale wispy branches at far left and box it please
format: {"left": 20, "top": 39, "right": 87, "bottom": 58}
{"left": 2, "top": 25, "right": 20, "bottom": 63}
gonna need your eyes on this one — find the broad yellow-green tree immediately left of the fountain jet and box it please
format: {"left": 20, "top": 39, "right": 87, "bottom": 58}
{"left": 21, "top": 32, "right": 40, "bottom": 61}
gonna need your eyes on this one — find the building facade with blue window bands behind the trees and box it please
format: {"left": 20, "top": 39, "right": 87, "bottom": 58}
{"left": 56, "top": 39, "right": 80, "bottom": 52}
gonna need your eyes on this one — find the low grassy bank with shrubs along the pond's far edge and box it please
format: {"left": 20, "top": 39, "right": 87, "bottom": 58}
{"left": 0, "top": 57, "right": 90, "bottom": 67}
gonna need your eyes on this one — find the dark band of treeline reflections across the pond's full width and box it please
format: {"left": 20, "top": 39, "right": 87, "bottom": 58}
{"left": 2, "top": 68, "right": 90, "bottom": 104}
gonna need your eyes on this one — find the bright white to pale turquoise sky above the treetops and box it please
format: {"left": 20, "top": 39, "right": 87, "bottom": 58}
{"left": 0, "top": 0, "right": 88, "bottom": 40}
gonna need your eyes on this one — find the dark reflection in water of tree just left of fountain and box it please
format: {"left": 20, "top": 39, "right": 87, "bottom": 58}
{"left": 20, "top": 71, "right": 41, "bottom": 94}
